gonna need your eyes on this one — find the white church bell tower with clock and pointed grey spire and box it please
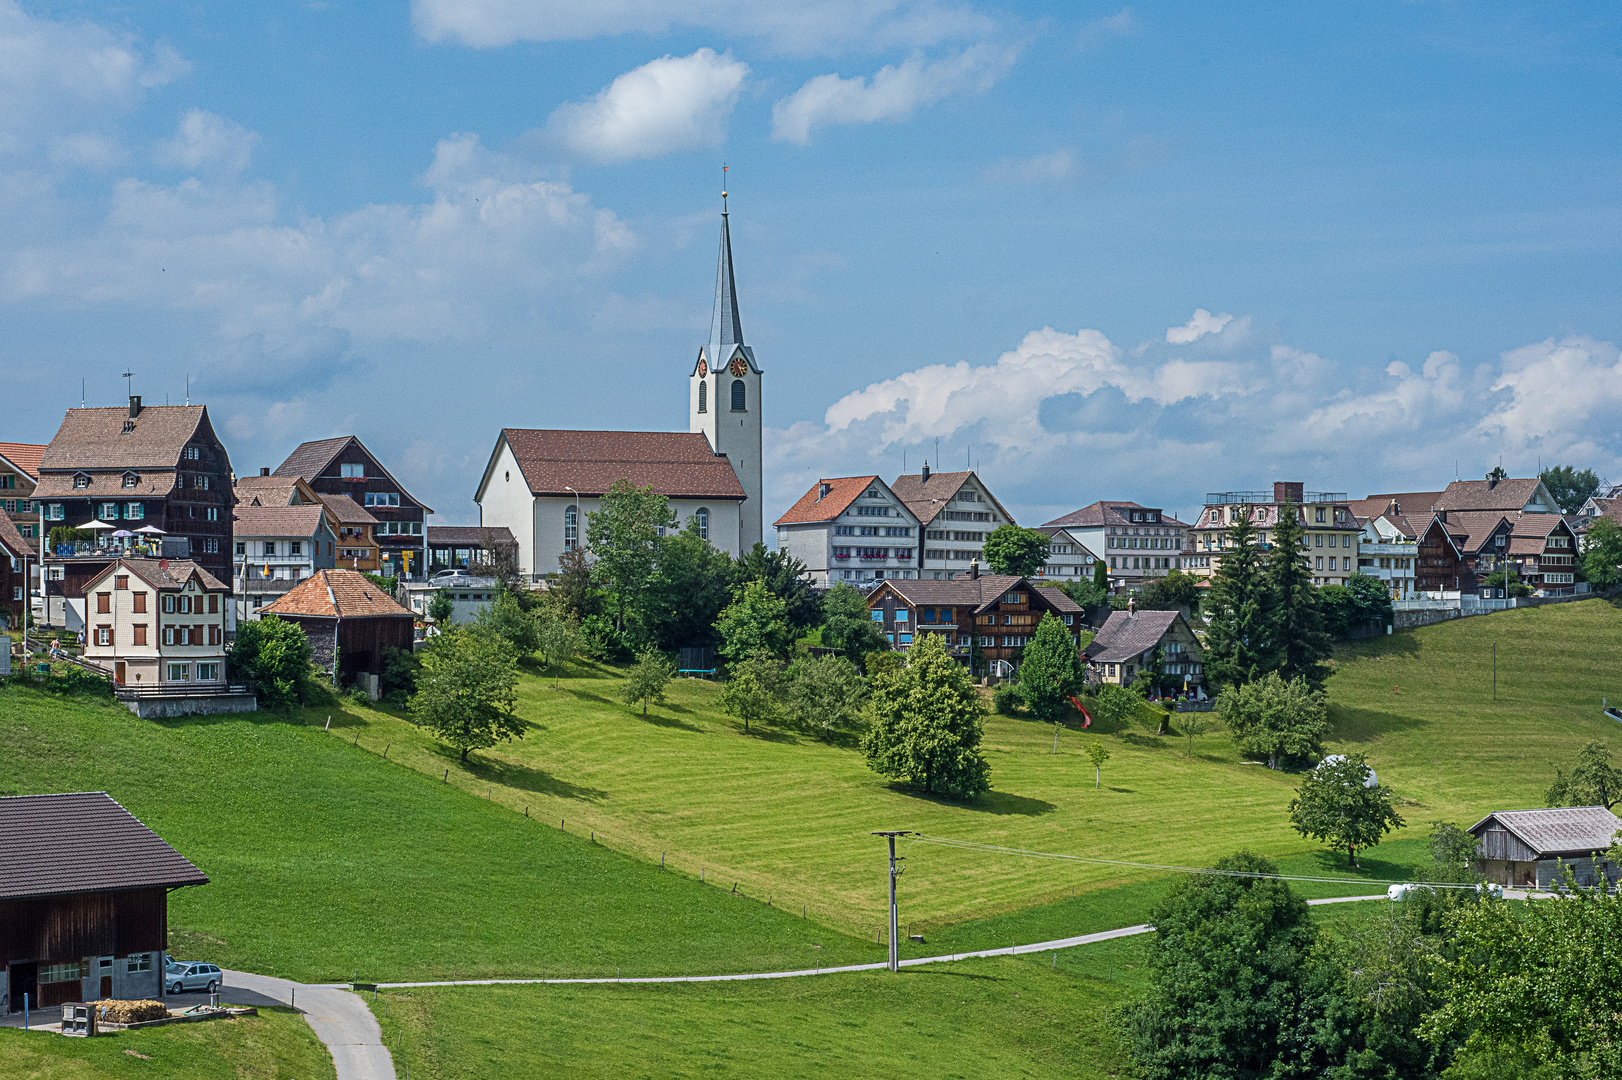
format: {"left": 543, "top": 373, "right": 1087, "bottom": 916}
{"left": 688, "top": 191, "right": 766, "bottom": 553}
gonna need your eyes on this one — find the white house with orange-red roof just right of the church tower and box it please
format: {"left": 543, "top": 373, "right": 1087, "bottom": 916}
{"left": 775, "top": 475, "right": 920, "bottom": 589}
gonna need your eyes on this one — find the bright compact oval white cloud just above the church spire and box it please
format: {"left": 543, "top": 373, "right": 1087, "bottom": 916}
{"left": 548, "top": 49, "right": 749, "bottom": 161}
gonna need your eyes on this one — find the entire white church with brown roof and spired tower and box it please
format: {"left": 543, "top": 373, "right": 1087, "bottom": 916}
{"left": 474, "top": 191, "right": 764, "bottom": 579}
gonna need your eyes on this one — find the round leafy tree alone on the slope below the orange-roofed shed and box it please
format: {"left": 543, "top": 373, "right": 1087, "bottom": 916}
{"left": 410, "top": 626, "right": 524, "bottom": 762}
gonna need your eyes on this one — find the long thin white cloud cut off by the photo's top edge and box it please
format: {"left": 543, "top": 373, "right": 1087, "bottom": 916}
{"left": 412, "top": 0, "right": 993, "bottom": 55}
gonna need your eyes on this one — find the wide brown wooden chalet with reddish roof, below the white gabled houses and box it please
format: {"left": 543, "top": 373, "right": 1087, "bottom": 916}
{"left": 868, "top": 563, "right": 1082, "bottom": 675}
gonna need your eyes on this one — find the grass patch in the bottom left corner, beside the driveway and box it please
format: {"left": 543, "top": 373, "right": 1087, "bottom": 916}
{"left": 0, "top": 1007, "right": 336, "bottom": 1080}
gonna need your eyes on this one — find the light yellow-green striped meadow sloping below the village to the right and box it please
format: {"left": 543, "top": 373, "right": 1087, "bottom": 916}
{"left": 326, "top": 600, "right": 1622, "bottom": 939}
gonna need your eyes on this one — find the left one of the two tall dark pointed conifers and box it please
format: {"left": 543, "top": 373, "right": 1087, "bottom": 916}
{"left": 1205, "top": 506, "right": 1273, "bottom": 686}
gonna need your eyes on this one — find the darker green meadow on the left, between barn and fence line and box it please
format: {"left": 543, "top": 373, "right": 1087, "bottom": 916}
{"left": 0, "top": 688, "right": 882, "bottom": 981}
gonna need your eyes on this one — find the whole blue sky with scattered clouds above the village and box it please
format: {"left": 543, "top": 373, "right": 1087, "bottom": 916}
{"left": 0, "top": 0, "right": 1622, "bottom": 532}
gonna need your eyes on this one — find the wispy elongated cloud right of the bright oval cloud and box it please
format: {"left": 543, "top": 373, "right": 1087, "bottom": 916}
{"left": 772, "top": 44, "right": 1019, "bottom": 144}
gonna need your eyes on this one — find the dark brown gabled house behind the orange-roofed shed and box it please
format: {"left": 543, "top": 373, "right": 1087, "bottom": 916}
{"left": 271, "top": 435, "right": 433, "bottom": 579}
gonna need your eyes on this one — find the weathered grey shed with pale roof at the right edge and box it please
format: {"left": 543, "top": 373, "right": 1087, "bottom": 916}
{"left": 1470, "top": 806, "right": 1622, "bottom": 889}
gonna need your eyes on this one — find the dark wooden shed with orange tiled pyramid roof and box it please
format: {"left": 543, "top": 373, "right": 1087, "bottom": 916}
{"left": 260, "top": 569, "right": 415, "bottom": 699}
